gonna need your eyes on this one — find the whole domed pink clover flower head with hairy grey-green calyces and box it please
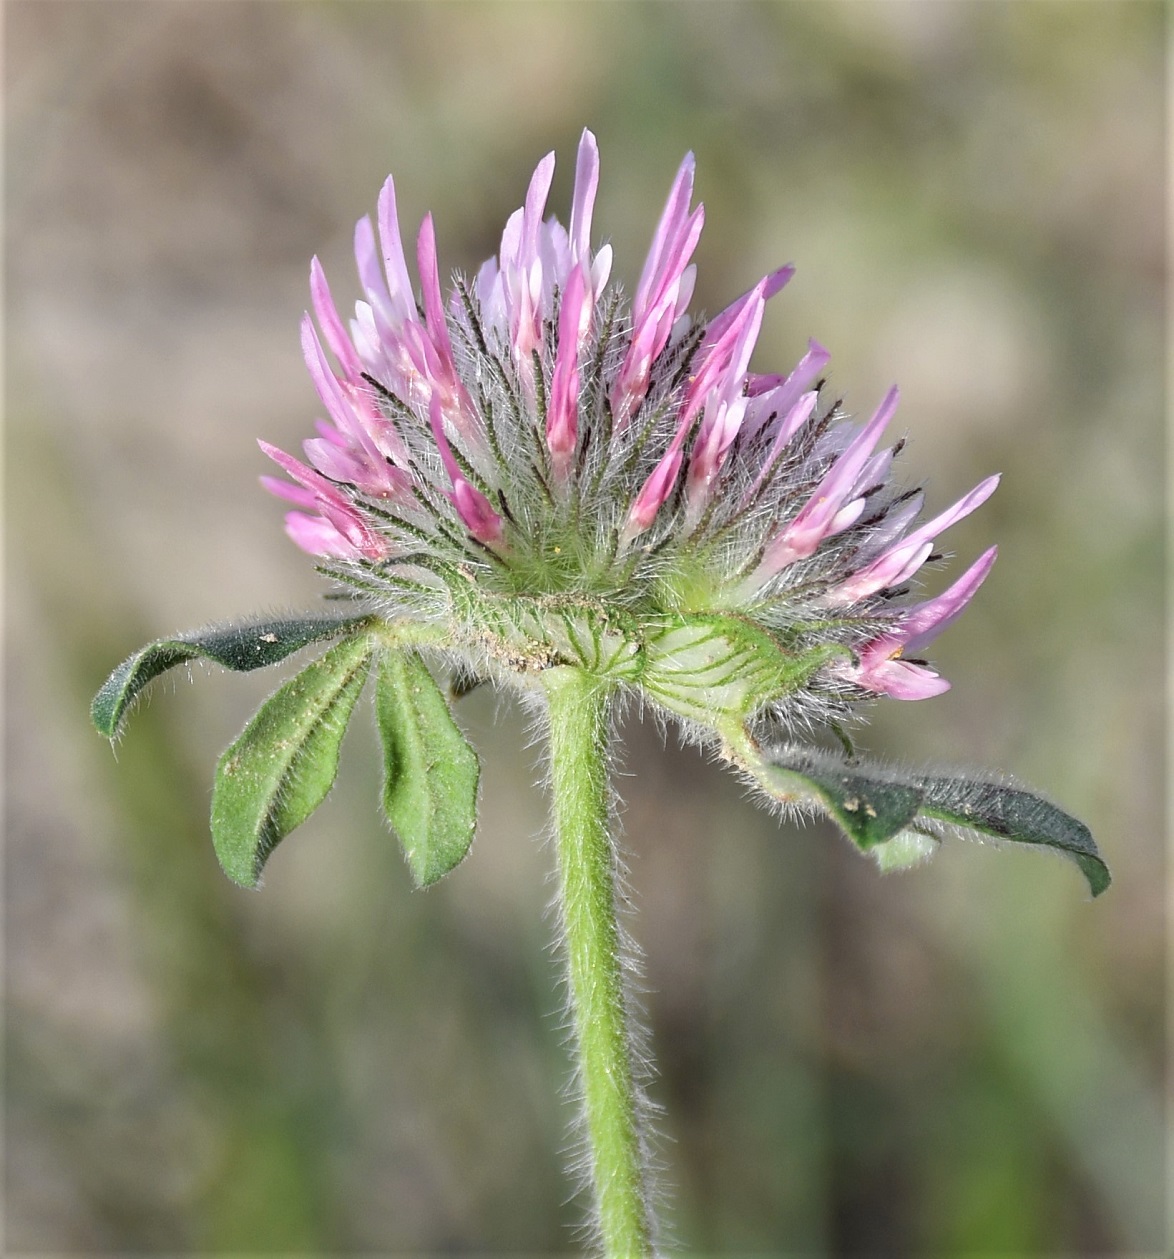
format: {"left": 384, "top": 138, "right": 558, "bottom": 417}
{"left": 262, "top": 131, "right": 998, "bottom": 745}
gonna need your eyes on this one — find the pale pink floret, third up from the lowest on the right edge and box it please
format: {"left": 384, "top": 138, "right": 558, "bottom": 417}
{"left": 752, "top": 385, "right": 898, "bottom": 584}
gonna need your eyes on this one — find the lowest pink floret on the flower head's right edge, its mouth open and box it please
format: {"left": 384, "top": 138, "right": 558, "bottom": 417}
{"left": 835, "top": 546, "right": 999, "bottom": 700}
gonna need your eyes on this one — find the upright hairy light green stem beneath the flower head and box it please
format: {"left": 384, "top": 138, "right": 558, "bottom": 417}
{"left": 543, "top": 666, "right": 651, "bottom": 1259}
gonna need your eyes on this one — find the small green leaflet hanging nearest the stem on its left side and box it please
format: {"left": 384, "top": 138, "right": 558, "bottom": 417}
{"left": 375, "top": 651, "right": 481, "bottom": 888}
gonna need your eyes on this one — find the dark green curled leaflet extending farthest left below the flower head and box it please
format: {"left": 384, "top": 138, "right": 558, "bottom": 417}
{"left": 89, "top": 612, "right": 370, "bottom": 739}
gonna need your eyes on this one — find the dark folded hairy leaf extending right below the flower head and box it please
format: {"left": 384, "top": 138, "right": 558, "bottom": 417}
{"left": 744, "top": 747, "right": 1110, "bottom": 896}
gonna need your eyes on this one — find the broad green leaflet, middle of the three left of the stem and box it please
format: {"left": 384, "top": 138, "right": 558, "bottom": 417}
{"left": 212, "top": 635, "right": 374, "bottom": 888}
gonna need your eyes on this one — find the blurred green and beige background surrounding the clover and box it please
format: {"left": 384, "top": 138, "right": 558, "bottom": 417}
{"left": 5, "top": 0, "right": 1168, "bottom": 1255}
